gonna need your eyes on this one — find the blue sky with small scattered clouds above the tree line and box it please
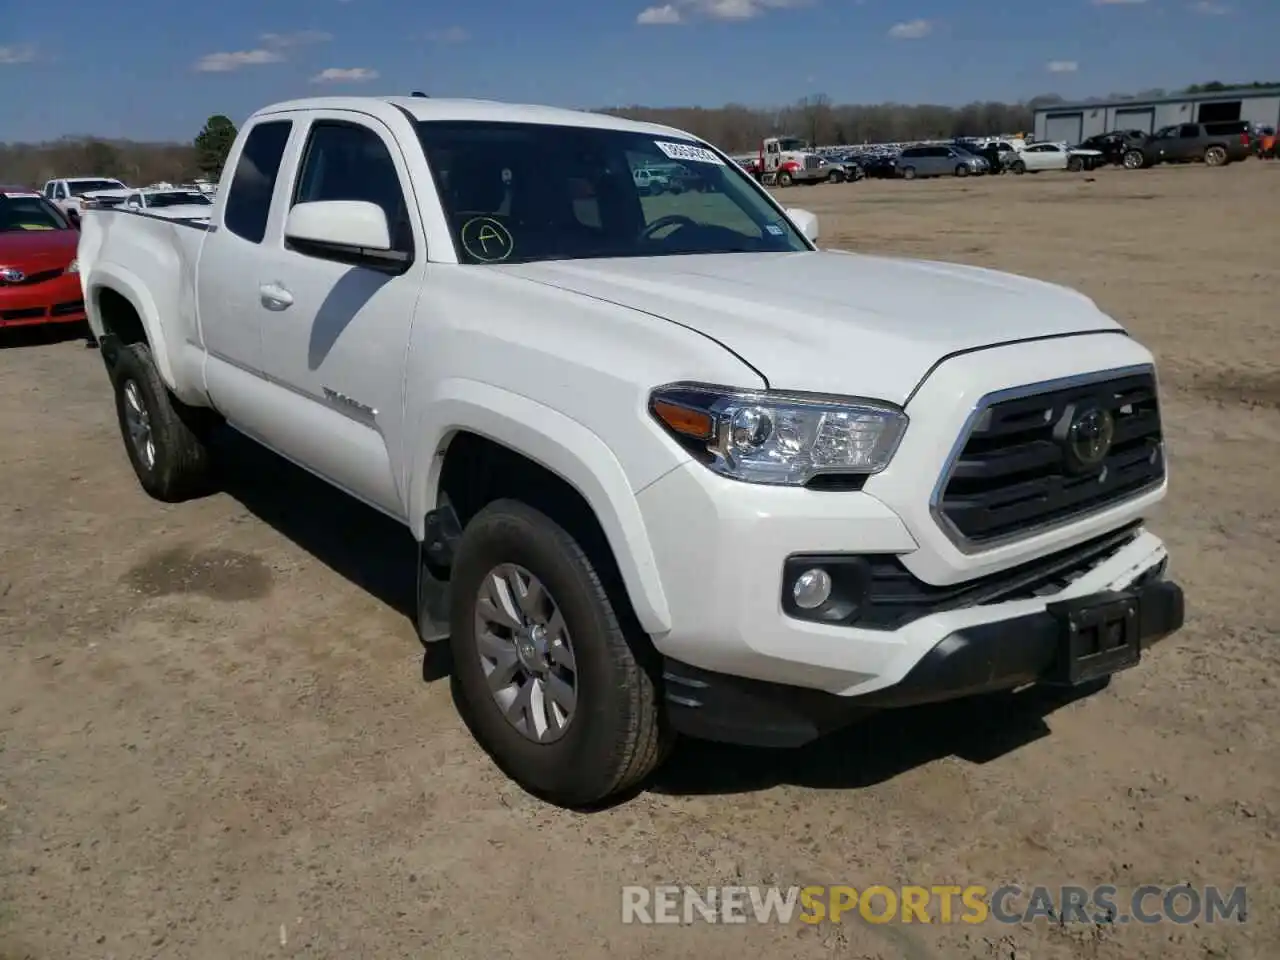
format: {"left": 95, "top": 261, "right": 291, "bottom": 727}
{"left": 0, "top": 0, "right": 1280, "bottom": 141}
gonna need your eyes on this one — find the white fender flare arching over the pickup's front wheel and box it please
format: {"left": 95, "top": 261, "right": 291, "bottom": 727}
{"left": 407, "top": 379, "right": 671, "bottom": 636}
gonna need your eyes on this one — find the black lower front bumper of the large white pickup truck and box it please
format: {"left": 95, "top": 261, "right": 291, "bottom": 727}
{"left": 663, "top": 580, "right": 1184, "bottom": 748}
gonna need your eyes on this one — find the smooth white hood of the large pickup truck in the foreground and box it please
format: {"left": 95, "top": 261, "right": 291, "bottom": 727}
{"left": 499, "top": 251, "right": 1123, "bottom": 404}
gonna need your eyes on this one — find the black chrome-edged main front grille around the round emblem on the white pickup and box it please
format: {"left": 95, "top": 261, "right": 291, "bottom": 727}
{"left": 933, "top": 370, "right": 1165, "bottom": 547}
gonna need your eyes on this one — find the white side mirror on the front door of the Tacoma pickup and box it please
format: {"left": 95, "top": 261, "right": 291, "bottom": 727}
{"left": 284, "top": 200, "right": 413, "bottom": 274}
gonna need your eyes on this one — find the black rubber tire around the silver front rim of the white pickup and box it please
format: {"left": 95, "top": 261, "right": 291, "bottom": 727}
{"left": 449, "top": 500, "right": 672, "bottom": 808}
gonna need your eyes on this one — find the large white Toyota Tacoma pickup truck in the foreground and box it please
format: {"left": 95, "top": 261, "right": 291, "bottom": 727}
{"left": 79, "top": 97, "right": 1183, "bottom": 805}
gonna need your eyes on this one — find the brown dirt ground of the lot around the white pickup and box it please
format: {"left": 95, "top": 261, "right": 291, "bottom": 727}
{"left": 0, "top": 161, "right": 1280, "bottom": 960}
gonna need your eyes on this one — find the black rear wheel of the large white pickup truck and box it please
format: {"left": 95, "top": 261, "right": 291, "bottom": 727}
{"left": 111, "top": 343, "right": 212, "bottom": 503}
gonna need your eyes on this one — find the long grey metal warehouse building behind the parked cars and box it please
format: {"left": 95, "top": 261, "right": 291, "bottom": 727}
{"left": 1036, "top": 87, "right": 1280, "bottom": 143}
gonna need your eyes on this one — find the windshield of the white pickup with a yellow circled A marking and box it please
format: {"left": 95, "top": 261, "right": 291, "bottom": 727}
{"left": 417, "top": 120, "right": 809, "bottom": 264}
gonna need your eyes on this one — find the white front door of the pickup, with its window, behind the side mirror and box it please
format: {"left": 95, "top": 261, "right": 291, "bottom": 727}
{"left": 256, "top": 110, "right": 426, "bottom": 520}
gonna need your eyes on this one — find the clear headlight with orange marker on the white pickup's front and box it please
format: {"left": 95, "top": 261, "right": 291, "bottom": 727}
{"left": 649, "top": 383, "right": 908, "bottom": 486}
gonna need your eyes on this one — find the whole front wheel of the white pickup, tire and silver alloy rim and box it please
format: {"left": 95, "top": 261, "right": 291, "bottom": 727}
{"left": 449, "top": 500, "right": 672, "bottom": 808}
